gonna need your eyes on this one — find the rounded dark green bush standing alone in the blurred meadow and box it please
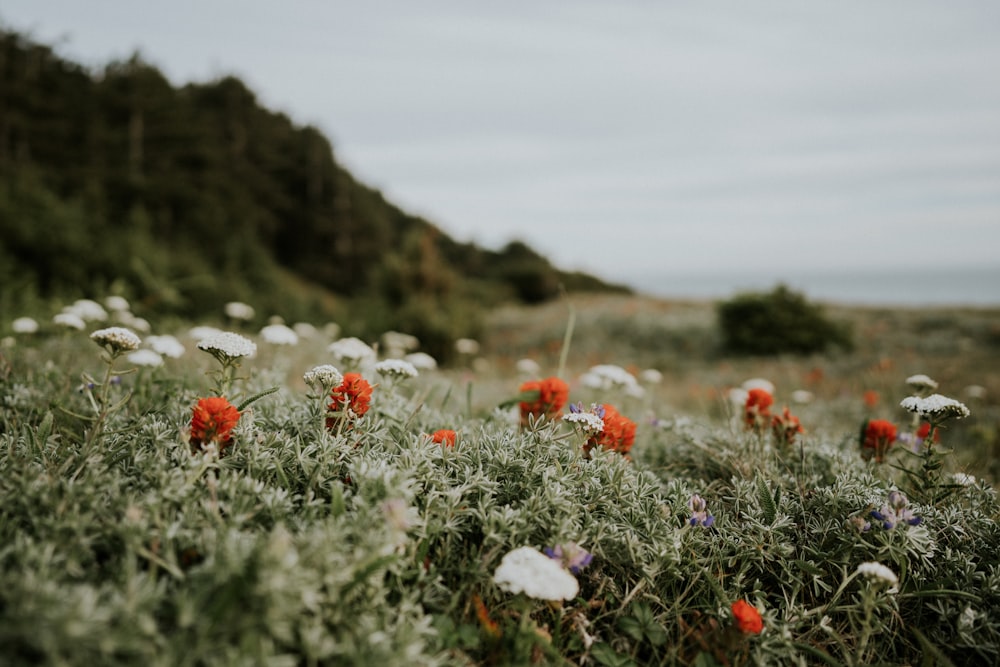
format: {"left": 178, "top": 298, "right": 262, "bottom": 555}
{"left": 718, "top": 285, "right": 854, "bottom": 355}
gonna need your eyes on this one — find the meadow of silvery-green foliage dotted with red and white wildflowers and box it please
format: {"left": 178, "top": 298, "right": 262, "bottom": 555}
{"left": 0, "top": 297, "right": 1000, "bottom": 666}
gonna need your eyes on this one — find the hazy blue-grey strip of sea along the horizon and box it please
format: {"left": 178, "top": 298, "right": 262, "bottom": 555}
{"left": 619, "top": 265, "right": 1000, "bottom": 307}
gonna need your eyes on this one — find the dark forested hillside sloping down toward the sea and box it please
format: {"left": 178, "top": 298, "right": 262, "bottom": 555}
{"left": 0, "top": 30, "right": 624, "bottom": 358}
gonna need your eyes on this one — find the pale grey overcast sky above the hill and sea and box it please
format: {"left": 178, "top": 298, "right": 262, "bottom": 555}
{"left": 0, "top": 0, "right": 1000, "bottom": 300}
